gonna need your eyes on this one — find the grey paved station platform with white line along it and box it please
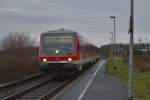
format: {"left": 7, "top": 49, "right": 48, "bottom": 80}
{"left": 52, "top": 60, "right": 128, "bottom": 100}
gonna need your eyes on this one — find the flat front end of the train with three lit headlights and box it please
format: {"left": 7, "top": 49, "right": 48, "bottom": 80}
{"left": 39, "top": 30, "right": 79, "bottom": 72}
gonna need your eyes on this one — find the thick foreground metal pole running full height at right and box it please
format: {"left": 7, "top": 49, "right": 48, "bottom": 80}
{"left": 128, "top": 0, "right": 134, "bottom": 100}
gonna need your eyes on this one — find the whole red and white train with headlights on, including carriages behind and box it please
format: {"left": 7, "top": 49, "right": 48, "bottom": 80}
{"left": 39, "top": 29, "right": 100, "bottom": 71}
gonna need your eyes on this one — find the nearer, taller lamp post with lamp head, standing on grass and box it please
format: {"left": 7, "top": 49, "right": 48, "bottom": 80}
{"left": 109, "top": 16, "right": 116, "bottom": 68}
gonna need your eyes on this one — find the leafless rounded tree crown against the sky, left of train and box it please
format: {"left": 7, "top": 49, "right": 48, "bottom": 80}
{"left": 1, "top": 32, "right": 35, "bottom": 50}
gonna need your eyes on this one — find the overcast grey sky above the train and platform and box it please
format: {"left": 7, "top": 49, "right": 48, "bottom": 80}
{"left": 0, "top": 0, "right": 150, "bottom": 46}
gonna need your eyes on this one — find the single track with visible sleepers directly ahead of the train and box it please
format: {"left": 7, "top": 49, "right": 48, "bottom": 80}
{"left": 3, "top": 79, "right": 69, "bottom": 100}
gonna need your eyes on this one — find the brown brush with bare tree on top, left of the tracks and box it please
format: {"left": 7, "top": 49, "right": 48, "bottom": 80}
{"left": 0, "top": 32, "right": 40, "bottom": 84}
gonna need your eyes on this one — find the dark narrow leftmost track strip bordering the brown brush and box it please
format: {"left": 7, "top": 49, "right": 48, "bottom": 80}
{"left": 0, "top": 74, "right": 50, "bottom": 100}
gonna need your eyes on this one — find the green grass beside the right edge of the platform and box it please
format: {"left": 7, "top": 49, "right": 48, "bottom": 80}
{"left": 106, "top": 57, "right": 150, "bottom": 100}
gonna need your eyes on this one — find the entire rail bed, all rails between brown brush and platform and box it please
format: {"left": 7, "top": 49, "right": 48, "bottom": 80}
{"left": 0, "top": 72, "right": 79, "bottom": 100}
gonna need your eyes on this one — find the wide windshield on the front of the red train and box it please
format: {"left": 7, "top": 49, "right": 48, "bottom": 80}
{"left": 43, "top": 36, "right": 73, "bottom": 55}
